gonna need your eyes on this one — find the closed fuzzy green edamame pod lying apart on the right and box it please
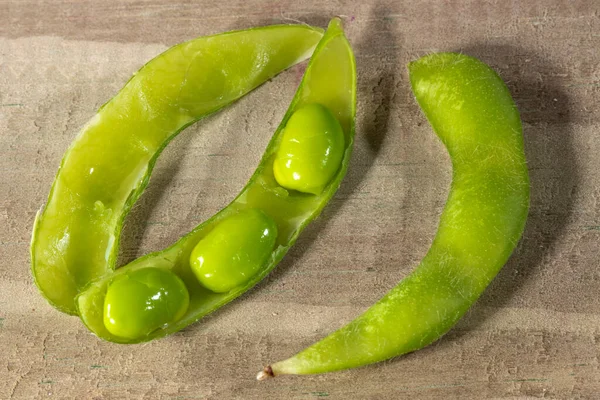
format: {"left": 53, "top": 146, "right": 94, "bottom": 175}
{"left": 257, "top": 53, "right": 529, "bottom": 380}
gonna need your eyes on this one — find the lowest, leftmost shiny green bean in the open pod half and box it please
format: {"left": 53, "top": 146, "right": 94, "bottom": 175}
{"left": 104, "top": 268, "right": 189, "bottom": 339}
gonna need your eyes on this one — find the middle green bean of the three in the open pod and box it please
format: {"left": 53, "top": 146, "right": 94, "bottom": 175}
{"left": 190, "top": 208, "right": 277, "bottom": 293}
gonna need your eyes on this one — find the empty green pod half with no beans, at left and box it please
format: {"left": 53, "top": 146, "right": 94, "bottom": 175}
{"left": 31, "top": 25, "right": 323, "bottom": 314}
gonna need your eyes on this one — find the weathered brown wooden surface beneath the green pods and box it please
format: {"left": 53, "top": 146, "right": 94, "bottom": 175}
{"left": 0, "top": 0, "right": 600, "bottom": 400}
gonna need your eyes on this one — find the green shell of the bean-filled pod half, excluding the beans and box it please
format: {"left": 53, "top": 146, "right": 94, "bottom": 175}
{"left": 76, "top": 19, "right": 356, "bottom": 343}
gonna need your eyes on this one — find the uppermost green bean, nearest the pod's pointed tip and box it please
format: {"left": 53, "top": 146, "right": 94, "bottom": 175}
{"left": 273, "top": 103, "right": 344, "bottom": 194}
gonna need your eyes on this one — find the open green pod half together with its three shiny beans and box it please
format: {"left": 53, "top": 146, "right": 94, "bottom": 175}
{"left": 76, "top": 18, "right": 356, "bottom": 343}
